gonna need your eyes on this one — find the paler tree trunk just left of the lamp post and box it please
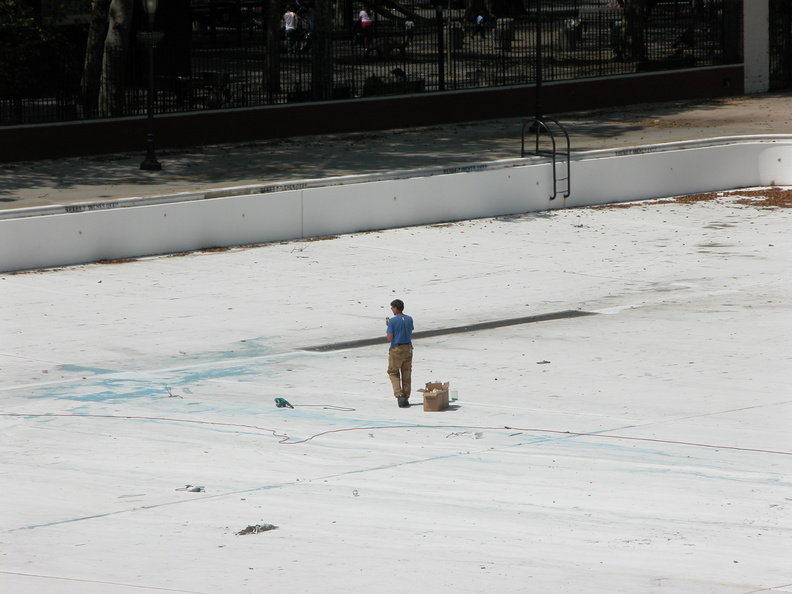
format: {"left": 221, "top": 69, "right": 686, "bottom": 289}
{"left": 99, "top": 0, "right": 133, "bottom": 117}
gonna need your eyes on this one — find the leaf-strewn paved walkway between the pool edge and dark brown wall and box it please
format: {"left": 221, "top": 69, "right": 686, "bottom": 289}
{"left": 0, "top": 94, "right": 792, "bottom": 209}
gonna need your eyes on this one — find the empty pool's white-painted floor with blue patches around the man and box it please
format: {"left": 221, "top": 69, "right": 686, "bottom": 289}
{"left": 0, "top": 192, "right": 792, "bottom": 594}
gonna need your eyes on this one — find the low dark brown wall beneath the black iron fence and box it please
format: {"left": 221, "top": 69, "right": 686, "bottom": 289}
{"left": 0, "top": 65, "right": 743, "bottom": 162}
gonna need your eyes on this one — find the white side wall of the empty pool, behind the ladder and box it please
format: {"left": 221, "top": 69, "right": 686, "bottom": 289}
{"left": 0, "top": 136, "right": 792, "bottom": 271}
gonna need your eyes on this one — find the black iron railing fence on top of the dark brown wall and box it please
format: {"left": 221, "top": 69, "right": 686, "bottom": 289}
{"left": 0, "top": 0, "right": 742, "bottom": 125}
